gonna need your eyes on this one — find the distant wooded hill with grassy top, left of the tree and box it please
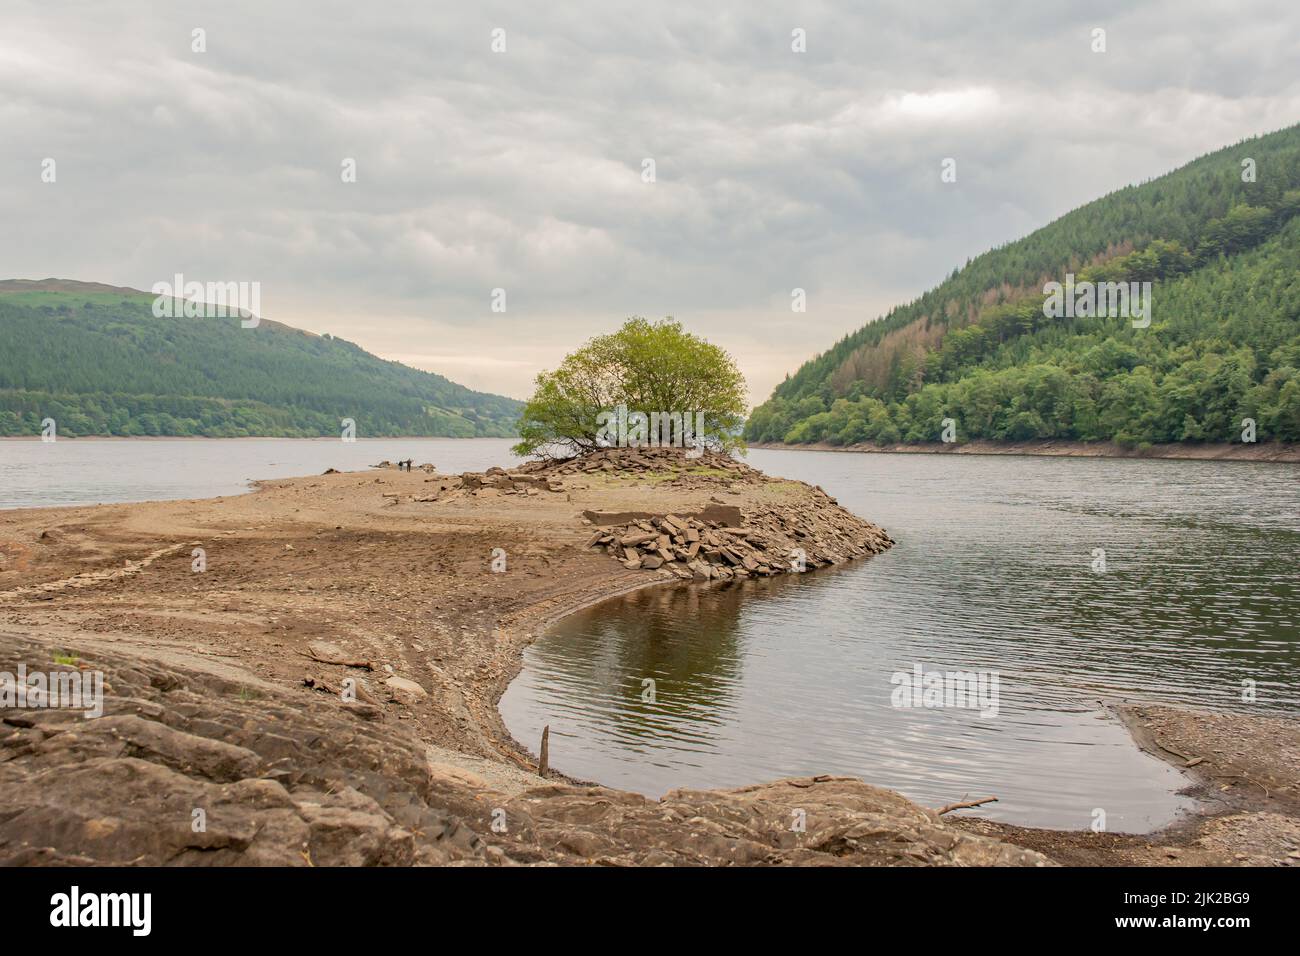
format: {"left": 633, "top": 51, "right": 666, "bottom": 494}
{"left": 0, "top": 280, "right": 523, "bottom": 438}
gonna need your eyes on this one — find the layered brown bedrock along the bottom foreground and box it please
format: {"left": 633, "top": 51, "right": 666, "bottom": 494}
{"left": 0, "top": 636, "right": 1047, "bottom": 866}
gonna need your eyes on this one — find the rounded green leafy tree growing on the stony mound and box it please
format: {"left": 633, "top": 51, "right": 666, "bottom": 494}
{"left": 514, "top": 316, "right": 745, "bottom": 457}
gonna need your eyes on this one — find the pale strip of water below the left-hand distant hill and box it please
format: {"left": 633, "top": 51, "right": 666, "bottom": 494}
{"left": 0, "top": 438, "right": 514, "bottom": 509}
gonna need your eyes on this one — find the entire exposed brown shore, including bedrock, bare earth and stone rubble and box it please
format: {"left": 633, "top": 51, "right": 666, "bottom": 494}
{"left": 0, "top": 454, "right": 1300, "bottom": 866}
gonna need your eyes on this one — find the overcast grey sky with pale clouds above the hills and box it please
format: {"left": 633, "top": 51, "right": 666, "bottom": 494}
{"left": 0, "top": 0, "right": 1300, "bottom": 401}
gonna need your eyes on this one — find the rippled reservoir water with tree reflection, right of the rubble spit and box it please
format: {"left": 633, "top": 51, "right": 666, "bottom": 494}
{"left": 501, "top": 451, "right": 1300, "bottom": 831}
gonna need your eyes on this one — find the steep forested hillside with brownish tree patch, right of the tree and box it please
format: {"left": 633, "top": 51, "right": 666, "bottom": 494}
{"left": 745, "top": 126, "right": 1300, "bottom": 445}
